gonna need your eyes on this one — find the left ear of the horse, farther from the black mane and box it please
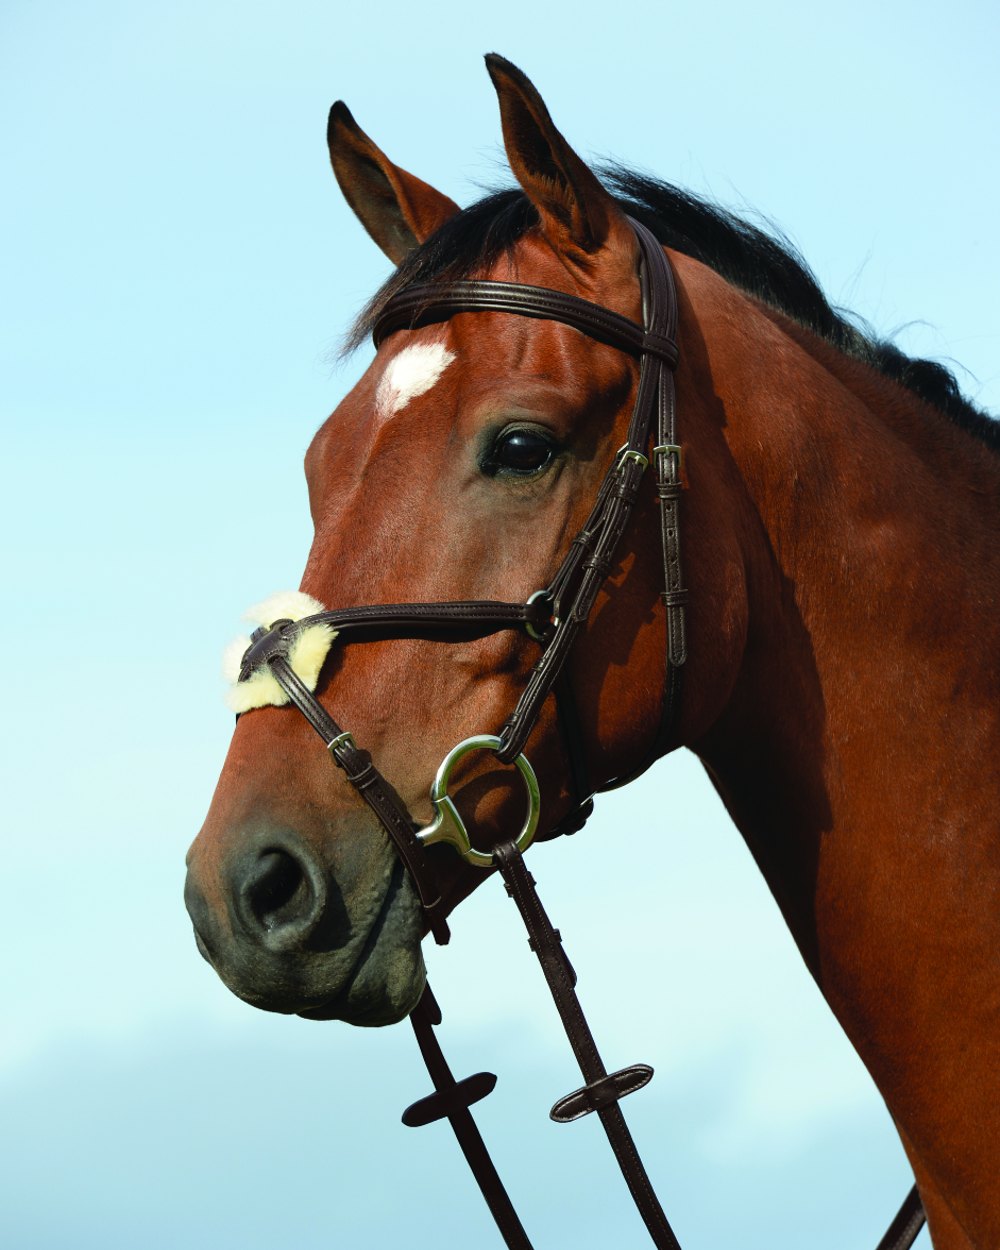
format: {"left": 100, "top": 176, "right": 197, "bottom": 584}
{"left": 326, "top": 100, "right": 459, "bottom": 265}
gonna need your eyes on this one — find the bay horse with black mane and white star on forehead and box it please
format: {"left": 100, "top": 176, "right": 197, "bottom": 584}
{"left": 186, "top": 56, "right": 1000, "bottom": 1250}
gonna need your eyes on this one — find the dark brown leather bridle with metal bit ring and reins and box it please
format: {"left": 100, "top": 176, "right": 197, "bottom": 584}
{"left": 232, "top": 220, "right": 924, "bottom": 1250}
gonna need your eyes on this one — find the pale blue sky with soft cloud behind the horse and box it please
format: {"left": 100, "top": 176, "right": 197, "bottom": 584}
{"left": 0, "top": 0, "right": 1000, "bottom": 1250}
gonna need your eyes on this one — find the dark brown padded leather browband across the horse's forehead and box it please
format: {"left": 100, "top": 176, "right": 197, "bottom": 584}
{"left": 371, "top": 279, "right": 678, "bottom": 369}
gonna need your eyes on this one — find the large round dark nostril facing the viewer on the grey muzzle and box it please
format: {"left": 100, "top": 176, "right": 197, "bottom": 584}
{"left": 234, "top": 846, "right": 326, "bottom": 948}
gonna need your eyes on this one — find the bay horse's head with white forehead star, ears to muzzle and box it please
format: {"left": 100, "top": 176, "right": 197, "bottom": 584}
{"left": 188, "top": 58, "right": 705, "bottom": 1024}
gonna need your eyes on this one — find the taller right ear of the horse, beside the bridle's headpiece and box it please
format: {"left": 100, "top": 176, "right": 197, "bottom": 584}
{"left": 486, "top": 53, "right": 625, "bottom": 254}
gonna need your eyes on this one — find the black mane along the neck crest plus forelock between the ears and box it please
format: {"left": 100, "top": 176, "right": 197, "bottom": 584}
{"left": 348, "top": 165, "right": 1000, "bottom": 451}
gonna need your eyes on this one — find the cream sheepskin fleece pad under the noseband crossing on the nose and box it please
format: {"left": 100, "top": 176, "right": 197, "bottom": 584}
{"left": 223, "top": 590, "right": 338, "bottom": 714}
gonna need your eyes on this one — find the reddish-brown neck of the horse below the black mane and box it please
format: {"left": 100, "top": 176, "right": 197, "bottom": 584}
{"left": 680, "top": 263, "right": 1000, "bottom": 1180}
